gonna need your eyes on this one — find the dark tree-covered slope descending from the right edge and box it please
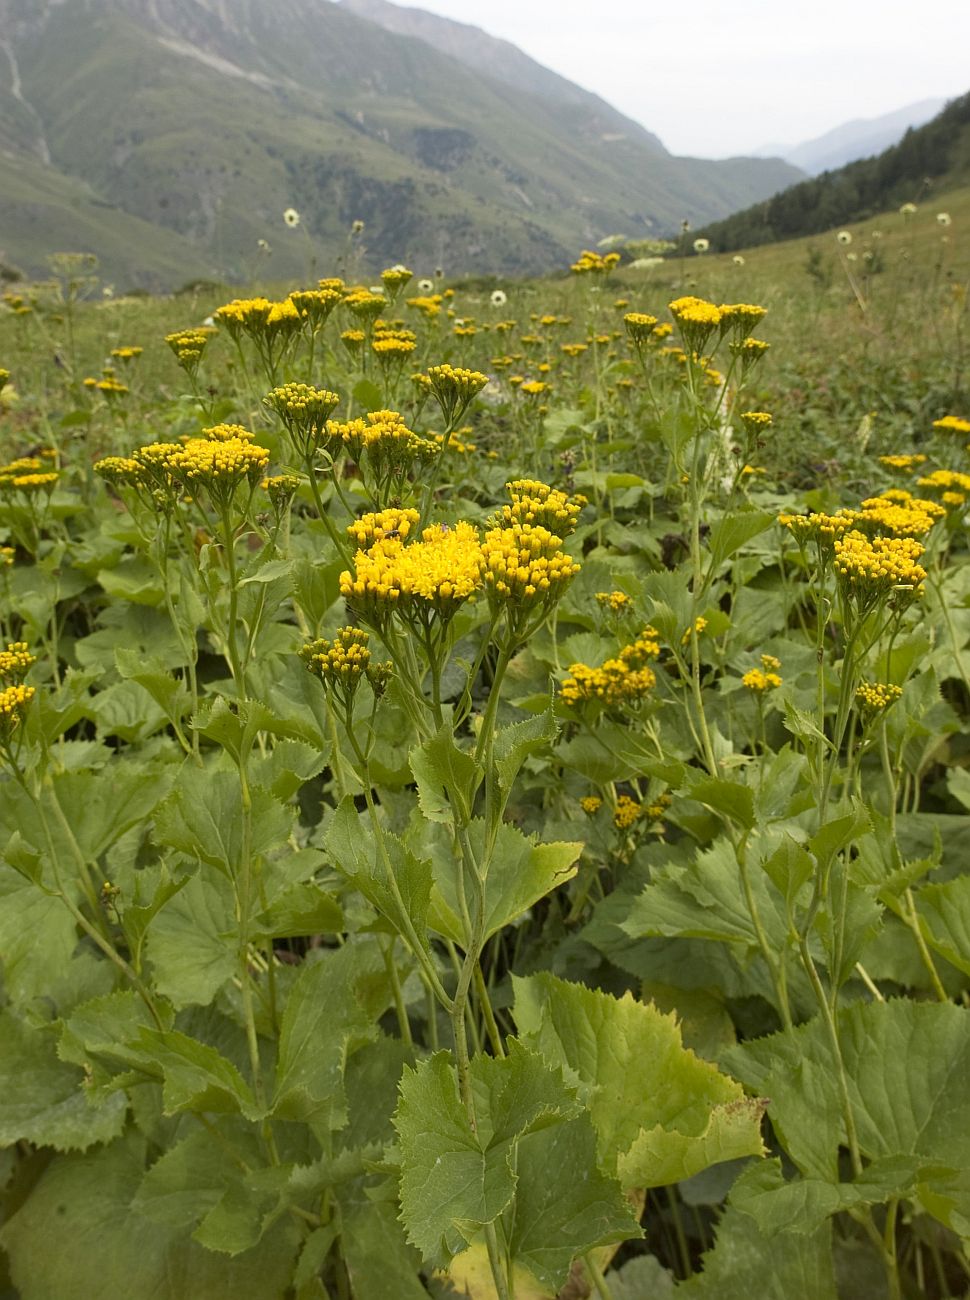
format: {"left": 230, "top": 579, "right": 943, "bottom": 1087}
{"left": 701, "top": 94, "right": 970, "bottom": 252}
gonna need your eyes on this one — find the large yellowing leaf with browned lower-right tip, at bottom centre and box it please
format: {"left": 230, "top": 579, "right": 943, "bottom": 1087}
{"left": 514, "top": 974, "right": 763, "bottom": 1188}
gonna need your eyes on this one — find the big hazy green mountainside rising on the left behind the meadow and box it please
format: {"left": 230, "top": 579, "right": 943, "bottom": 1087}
{"left": 0, "top": 0, "right": 798, "bottom": 286}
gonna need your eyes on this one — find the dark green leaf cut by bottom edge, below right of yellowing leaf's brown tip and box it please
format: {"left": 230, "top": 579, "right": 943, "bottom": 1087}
{"left": 676, "top": 1166, "right": 839, "bottom": 1300}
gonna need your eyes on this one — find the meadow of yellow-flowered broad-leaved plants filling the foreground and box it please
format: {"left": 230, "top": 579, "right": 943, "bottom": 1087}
{"left": 0, "top": 195, "right": 970, "bottom": 1300}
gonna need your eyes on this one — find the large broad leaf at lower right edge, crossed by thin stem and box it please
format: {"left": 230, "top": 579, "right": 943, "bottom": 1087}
{"left": 726, "top": 1000, "right": 970, "bottom": 1234}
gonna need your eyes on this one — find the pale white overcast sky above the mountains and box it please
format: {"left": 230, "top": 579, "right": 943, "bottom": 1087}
{"left": 390, "top": 0, "right": 970, "bottom": 157}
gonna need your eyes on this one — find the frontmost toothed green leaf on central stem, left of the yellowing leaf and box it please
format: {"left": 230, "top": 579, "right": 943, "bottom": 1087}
{"left": 394, "top": 1041, "right": 579, "bottom": 1265}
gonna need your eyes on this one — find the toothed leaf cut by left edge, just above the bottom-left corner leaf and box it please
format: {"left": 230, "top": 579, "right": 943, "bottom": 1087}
{"left": 0, "top": 1011, "right": 127, "bottom": 1151}
